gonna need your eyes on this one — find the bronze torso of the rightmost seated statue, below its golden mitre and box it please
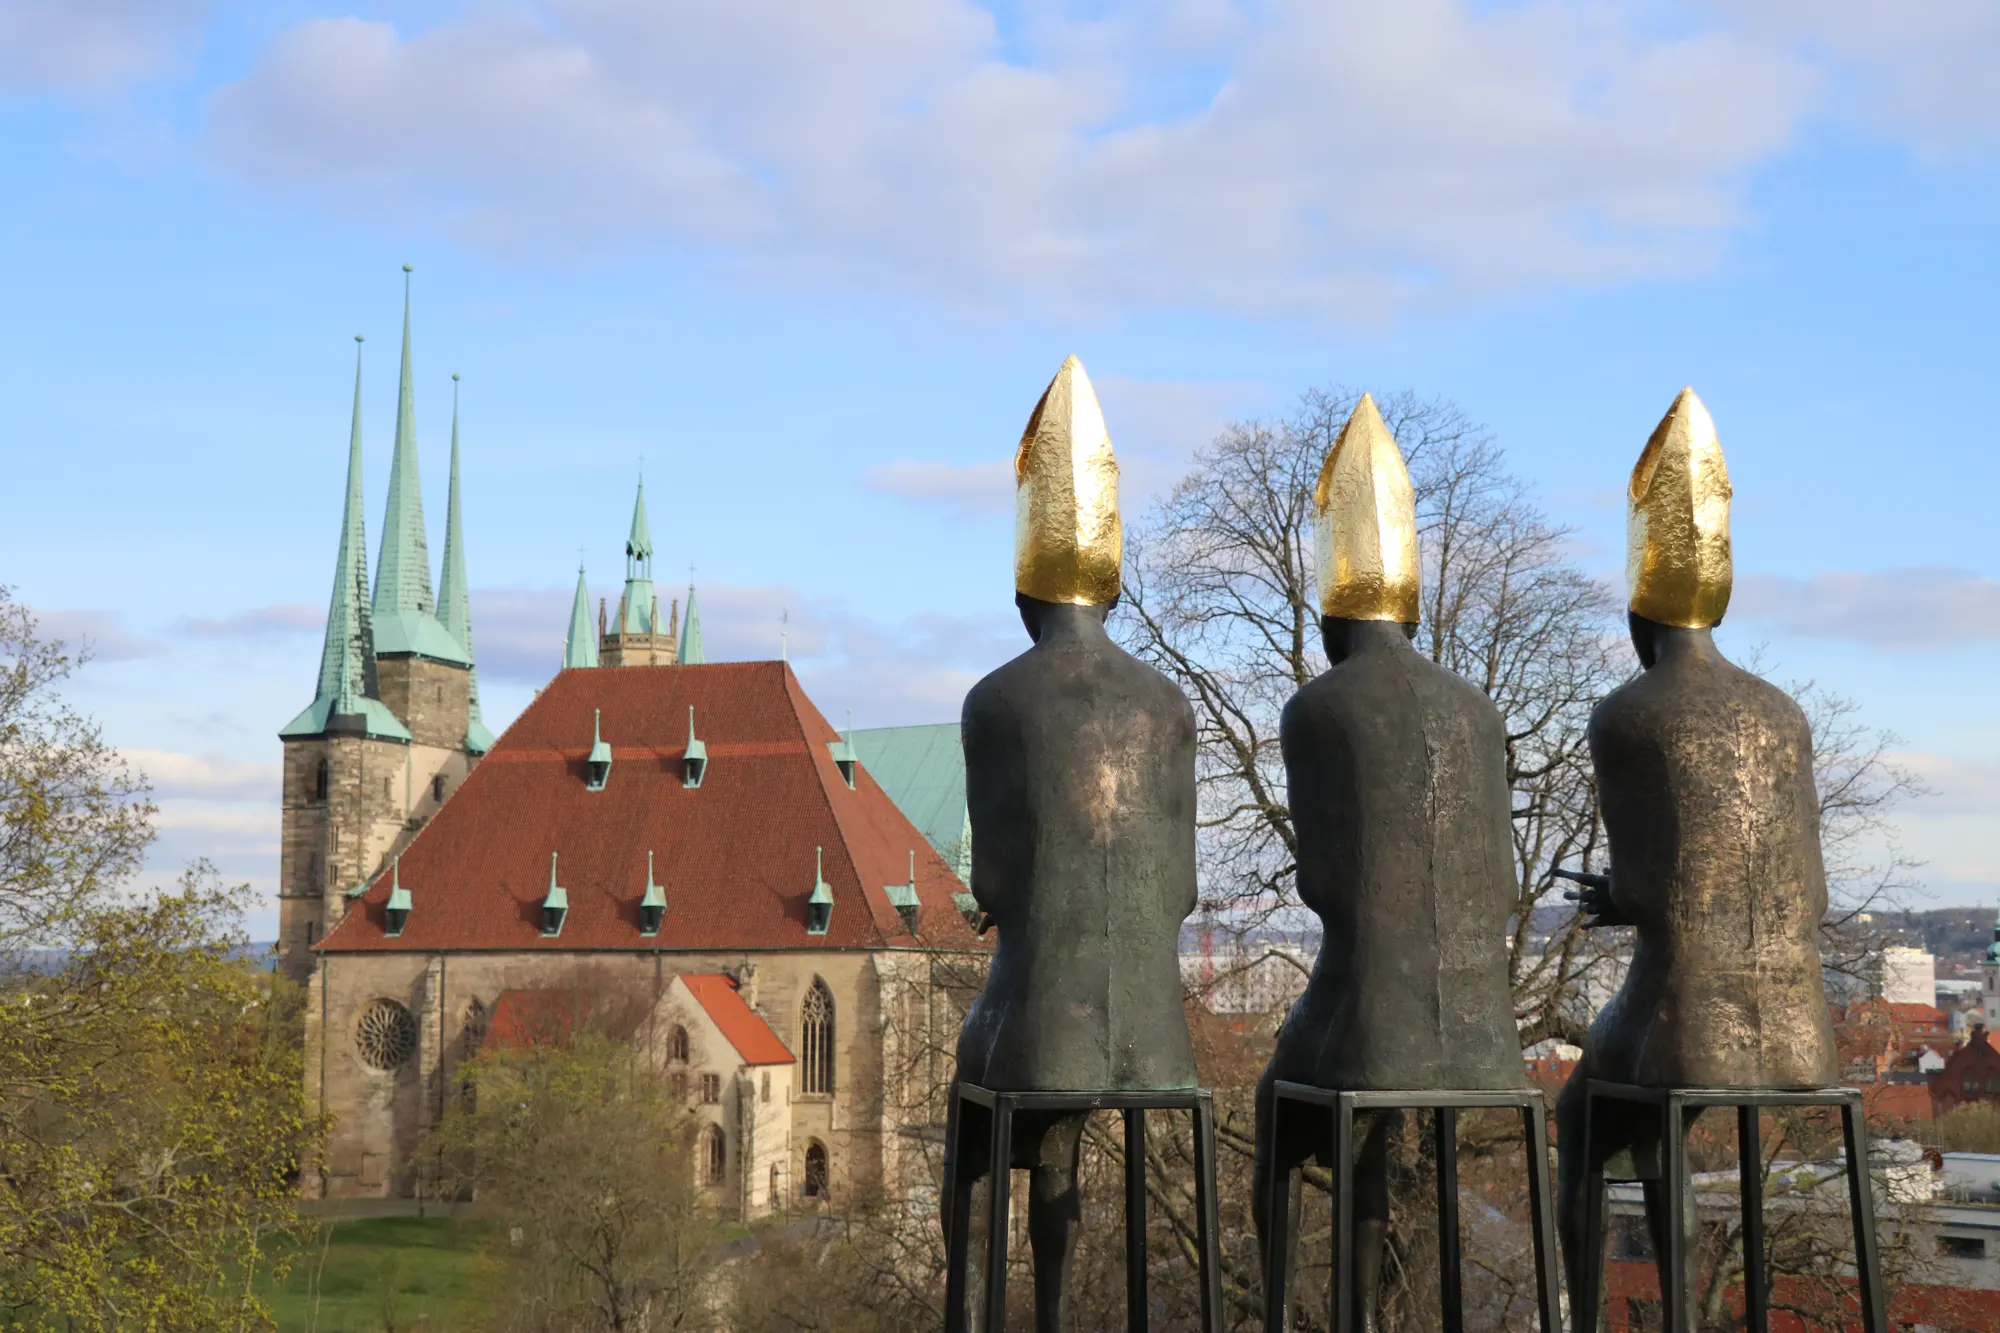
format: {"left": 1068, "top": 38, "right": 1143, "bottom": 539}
{"left": 1588, "top": 632, "right": 1838, "bottom": 1087}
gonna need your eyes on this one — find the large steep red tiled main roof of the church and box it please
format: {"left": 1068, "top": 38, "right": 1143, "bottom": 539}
{"left": 318, "top": 662, "right": 984, "bottom": 953}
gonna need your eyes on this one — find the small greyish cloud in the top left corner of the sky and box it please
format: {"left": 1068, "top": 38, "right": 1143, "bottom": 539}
{"left": 0, "top": 0, "right": 208, "bottom": 92}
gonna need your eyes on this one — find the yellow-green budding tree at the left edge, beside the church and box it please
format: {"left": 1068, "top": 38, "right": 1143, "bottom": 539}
{"left": 0, "top": 588, "right": 318, "bottom": 1333}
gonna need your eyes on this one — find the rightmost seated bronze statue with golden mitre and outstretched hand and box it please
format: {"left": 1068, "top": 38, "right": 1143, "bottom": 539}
{"left": 1556, "top": 388, "right": 1840, "bottom": 1329}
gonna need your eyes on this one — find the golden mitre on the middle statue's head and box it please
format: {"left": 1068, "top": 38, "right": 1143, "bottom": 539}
{"left": 1312, "top": 394, "right": 1424, "bottom": 624}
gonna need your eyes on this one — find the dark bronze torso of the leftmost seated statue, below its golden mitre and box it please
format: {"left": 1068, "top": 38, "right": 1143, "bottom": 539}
{"left": 958, "top": 606, "right": 1196, "bottom": 1091}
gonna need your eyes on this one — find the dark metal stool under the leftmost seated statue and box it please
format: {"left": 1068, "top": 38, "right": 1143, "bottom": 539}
{"left": 944, "top": 1083, "right": 1222, "bottom": 1333}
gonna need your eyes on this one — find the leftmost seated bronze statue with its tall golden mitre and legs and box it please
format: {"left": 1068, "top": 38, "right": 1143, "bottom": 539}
{"left": 946, "top": 356, "right": 1196, "bottom": 1333}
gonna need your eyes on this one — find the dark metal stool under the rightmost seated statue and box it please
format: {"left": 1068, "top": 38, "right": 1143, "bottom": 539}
{"left": 1576, "top": 1079, "right": 1888, "bottom": 1333}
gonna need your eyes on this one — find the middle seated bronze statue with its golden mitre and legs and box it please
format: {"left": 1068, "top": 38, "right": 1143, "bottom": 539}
{"left": 1254, "top": 396, "right": 1526, "bottom": 1331}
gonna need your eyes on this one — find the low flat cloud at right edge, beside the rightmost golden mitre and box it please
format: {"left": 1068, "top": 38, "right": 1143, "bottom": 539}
{"left": 1730, "top": 566, "right": 2000, "bottom": 650}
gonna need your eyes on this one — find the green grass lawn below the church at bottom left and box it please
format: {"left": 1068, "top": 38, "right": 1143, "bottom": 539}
{"left": 268, "top": 1217, "right": 490, "bottom": 1333}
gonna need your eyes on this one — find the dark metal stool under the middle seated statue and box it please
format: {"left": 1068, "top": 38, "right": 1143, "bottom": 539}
{"left": 1264, "top": 1081, "right": 1562, "bottom": 1333}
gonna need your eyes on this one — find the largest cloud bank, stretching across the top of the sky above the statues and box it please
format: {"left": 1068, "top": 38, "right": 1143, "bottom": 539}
{"left": 210, "top": 0, "right": 1812, "bottom": 320}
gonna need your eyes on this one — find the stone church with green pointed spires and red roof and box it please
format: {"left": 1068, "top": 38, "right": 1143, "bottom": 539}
{"left": 278, "top": 278, "right": 984, "bottom": 1219}
